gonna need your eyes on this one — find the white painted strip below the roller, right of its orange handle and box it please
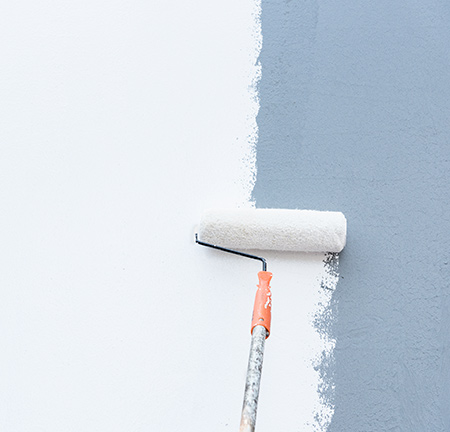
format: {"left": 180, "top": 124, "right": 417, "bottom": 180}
{"left": 250, "top": 252, "right": 334, "bottom": 432}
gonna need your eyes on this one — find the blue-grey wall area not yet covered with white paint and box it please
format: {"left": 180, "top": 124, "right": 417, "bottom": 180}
{"left": 254, "top": 0, "right": 450, "bottom": 432}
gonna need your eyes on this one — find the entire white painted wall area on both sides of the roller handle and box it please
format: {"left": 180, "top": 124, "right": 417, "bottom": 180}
{"left": 0, "top": 0, "right": 331, "bottom": 432}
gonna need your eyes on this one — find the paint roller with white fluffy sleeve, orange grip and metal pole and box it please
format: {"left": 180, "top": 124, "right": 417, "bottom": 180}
{"left": 195, "top": 209, "right": 347, "bottom": 432}
